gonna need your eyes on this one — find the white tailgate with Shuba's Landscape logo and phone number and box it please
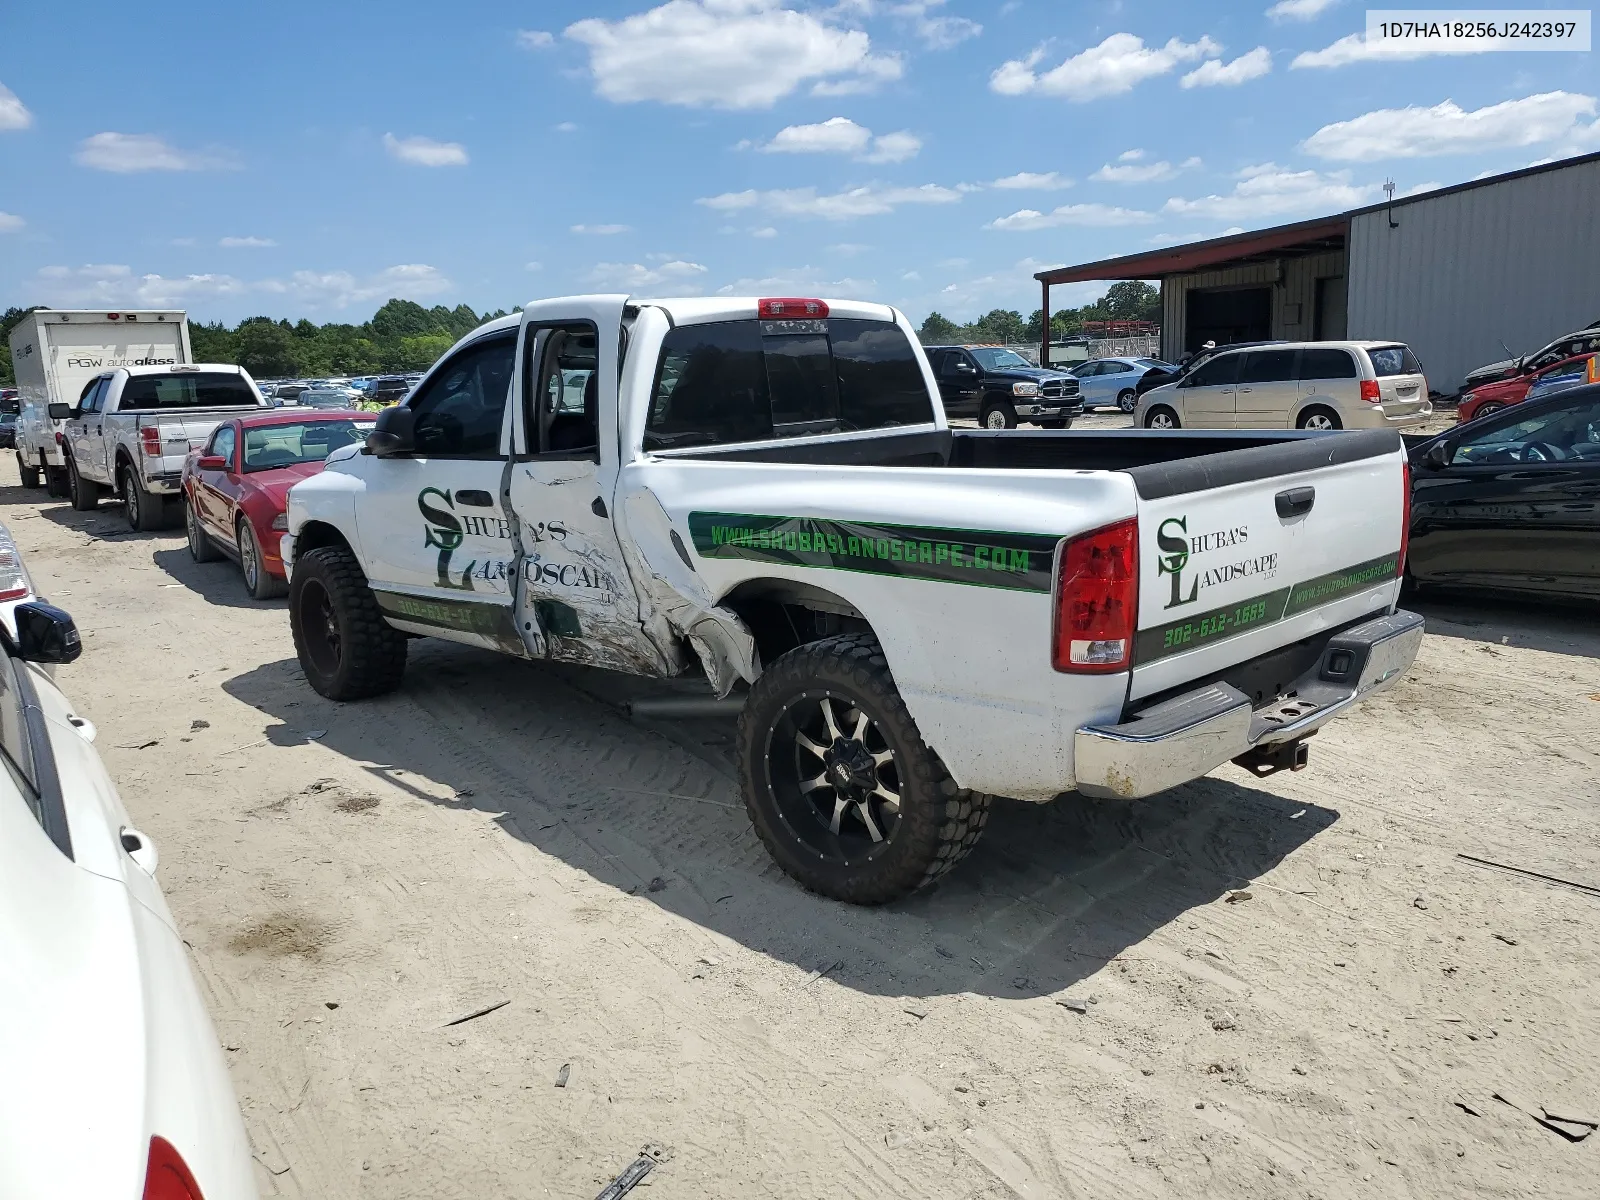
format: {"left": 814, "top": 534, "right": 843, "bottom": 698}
{"left": 1130, "top": 430, "right": 1405, "bottom": 699}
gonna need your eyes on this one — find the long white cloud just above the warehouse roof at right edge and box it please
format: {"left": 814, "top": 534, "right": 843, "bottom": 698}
{"left": 1301, "top": 91, "right": 1597, "bottom": 162}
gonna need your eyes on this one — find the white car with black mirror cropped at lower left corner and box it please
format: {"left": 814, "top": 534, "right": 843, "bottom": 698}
{"left": 0, "top": 603, "right": 256, "bottom": 1200}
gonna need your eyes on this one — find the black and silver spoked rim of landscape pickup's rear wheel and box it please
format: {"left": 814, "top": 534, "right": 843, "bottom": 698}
{"left": 766, "top": 693, "right": 901, "bottom": 862}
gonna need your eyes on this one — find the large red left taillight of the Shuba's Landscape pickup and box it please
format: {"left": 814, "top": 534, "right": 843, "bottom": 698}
{"left": 1051, "top": 520, "right": 1139, "bottom": 675}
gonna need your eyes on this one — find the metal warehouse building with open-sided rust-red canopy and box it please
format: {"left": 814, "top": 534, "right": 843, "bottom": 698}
{"left": 1034, "top": 154, "right": 1600, "bottom": 395}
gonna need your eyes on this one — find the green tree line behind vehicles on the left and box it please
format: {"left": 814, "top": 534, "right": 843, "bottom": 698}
{"left": 0, "top": 299, "right": 506, "bottom": 387}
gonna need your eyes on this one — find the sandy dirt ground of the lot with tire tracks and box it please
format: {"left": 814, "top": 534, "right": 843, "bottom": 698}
{"left": 0, "top": 459, "right": 1600, "bottom": 1200}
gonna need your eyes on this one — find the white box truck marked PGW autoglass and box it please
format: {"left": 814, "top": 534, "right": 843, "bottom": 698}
{"left": 11, "top": 309, "right": 192, "bottom": 496}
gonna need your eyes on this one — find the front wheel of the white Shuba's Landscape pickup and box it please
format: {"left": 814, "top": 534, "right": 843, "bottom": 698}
{"left": 290, "top": 546, "right": 406, "bottom": 701}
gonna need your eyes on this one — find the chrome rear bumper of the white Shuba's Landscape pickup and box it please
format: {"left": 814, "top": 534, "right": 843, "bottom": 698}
{"left": 1074, "top": 611, "right": 1422, "bottom": 800}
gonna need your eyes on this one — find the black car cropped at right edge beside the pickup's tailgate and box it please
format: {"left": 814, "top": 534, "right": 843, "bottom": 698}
{"left": 1406, "top": 386, "right": 1600, "bottom": 602}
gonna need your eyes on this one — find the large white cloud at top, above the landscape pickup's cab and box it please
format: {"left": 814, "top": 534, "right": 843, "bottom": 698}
{"left": 565, "top": 0, "right": 902, "bottom": 109}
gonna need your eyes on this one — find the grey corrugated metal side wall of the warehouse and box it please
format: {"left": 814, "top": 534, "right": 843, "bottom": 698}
{"left": 1349, "top": 162, "right": 1600, "bottom": 392}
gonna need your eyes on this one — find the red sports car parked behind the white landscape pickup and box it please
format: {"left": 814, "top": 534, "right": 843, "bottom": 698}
{"left": 184, "top": 408, "right": 378, "bottom": 600}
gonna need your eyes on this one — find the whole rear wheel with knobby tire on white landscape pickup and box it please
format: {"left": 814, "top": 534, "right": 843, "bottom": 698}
{"left": 738, "top": 634, "right": 990, "bottom": 904}
